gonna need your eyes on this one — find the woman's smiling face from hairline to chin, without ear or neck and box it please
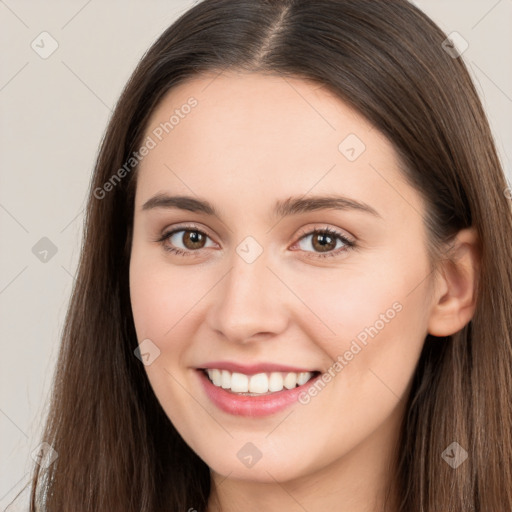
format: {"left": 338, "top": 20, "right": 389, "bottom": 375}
{"left": 130, "top": 73, "right": 430, "bottom": 482}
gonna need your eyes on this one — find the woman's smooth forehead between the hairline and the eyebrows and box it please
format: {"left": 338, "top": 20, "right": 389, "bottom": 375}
{"left": 137, "top": 72, "right": 422, "bottom": 222}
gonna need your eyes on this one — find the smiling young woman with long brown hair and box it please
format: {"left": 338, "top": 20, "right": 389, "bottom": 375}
{"left": 22, "top": 0, "right": 512, "bottom": 512}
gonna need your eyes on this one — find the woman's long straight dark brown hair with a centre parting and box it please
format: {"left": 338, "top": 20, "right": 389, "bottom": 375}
{"left": 25, "top": 0, "right": 512, "bottom": 512}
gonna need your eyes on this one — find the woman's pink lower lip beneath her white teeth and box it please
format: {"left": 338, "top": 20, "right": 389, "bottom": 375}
{"left": 197, "top": 370, "right": 320, "bottom": 417}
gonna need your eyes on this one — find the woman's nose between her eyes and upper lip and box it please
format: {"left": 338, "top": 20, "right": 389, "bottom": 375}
{"left": 207, "top": 245, "right": 290, "bottom": 343}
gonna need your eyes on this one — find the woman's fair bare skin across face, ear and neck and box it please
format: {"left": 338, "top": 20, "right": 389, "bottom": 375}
{"left": 130, "top": 72, "right": 477, "bottom": 512}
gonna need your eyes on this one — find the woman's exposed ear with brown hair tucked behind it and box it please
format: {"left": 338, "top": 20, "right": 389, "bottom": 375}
{"left": 428, "top": 228, "right": 480, "bottom": 337}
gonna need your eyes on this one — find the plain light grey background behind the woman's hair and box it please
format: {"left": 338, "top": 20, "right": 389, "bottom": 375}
{"left": 0, "top": 0, "right": 512, "bottom": 504}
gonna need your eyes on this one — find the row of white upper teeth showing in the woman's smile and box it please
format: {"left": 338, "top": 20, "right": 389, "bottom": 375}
{"left": 201, "top": 368, "right": 320, "bottom": 396}
